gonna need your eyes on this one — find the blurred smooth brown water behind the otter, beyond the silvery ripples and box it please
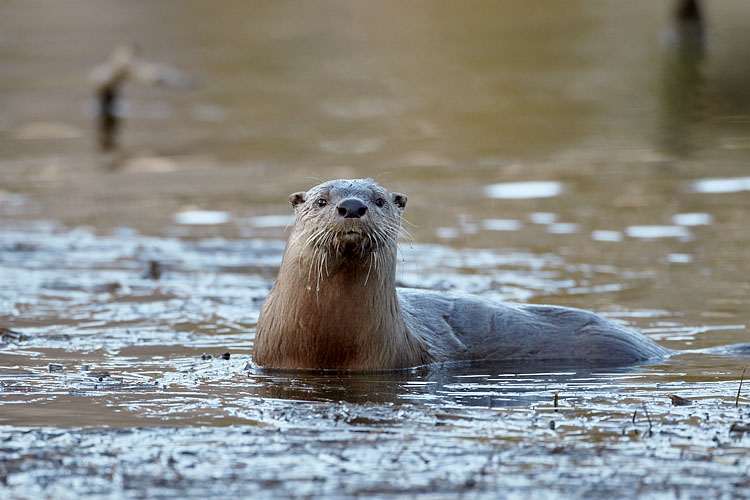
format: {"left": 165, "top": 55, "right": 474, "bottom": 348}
{"left": 0, "top": 0, "right": 750, "bottom": 336}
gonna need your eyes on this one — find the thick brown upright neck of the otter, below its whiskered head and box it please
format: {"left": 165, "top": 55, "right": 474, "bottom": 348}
{"left": 254, "top": 238, "right": 429, "bottom": 370}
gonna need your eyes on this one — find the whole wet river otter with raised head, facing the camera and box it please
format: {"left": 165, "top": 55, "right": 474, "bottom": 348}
{"left": 253, "top": 179, "right": 692, "bottom": 371}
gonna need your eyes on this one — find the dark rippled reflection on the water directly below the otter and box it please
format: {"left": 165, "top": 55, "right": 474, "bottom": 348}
{"left": 248, "top": 362, "right": 638, "bottom": 408}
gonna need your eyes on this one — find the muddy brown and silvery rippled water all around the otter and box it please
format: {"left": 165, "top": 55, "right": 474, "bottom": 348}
{"left": 0, "top": 0, "right": 750, "bottom": 498}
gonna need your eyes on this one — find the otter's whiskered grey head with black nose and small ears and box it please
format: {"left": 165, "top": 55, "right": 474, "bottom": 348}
{"left": 289, "top": 179, "right": 406, "bottom": 257}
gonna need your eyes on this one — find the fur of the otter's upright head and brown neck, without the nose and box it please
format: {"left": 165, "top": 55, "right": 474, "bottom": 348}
{"left": 253, "top": 179, "right": 432, "bottom": 370}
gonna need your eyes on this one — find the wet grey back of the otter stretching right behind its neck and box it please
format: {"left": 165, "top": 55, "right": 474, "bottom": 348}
{"left": 398, "top": 288, "right": 669, "bottom": 364}
